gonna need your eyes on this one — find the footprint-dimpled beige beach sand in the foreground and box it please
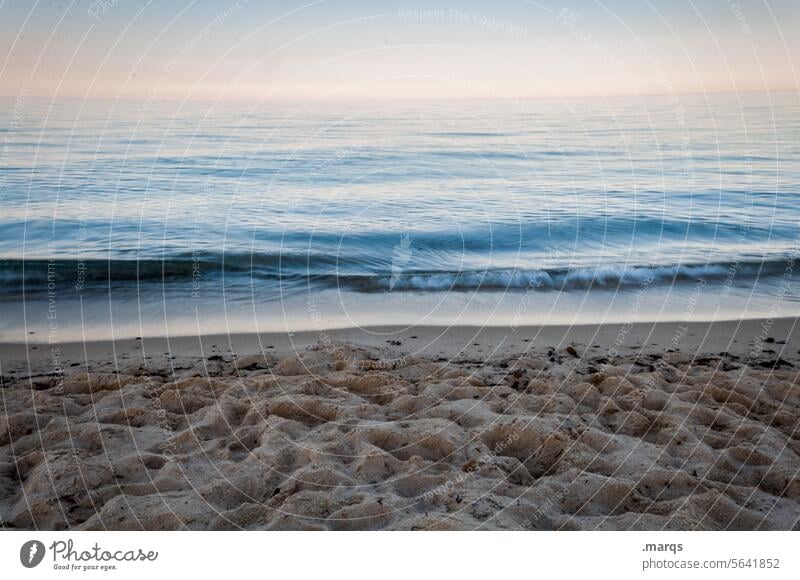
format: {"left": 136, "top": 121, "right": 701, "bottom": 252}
{"left": 0, "top": 319, "right": 800, "bottom": 530}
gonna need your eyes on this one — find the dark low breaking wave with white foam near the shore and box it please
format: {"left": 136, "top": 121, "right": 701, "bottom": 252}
{"left": 0, "top": 254, "right": 790, "bottom": 292}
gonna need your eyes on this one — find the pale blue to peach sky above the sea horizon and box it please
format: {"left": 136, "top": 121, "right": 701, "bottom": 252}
{"left": 0, "top": 0, "right": 800, "bottom": 101}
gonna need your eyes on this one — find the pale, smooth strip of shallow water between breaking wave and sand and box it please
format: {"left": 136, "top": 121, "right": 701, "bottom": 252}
{"left": 0, "top": 278, "right": 800, "bottom": 344}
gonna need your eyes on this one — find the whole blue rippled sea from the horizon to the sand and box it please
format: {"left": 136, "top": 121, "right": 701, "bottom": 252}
{"left": 0, "top": 93, "right": 800, "bottom": 340}
